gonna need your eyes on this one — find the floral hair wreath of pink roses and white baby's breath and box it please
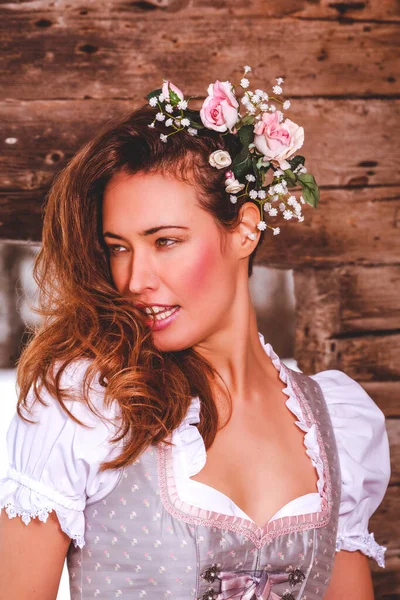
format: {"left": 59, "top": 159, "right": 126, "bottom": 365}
{"left": 146, "top": 66, "right": 319, "bottom": 240}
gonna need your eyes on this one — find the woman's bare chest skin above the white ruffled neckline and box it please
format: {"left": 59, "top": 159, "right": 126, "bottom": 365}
{"left": 190, "top": 390, "right": 318, "bottom": 527}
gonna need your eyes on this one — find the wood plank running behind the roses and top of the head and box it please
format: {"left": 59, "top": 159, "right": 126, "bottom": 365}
{"left": 0, "top": 94, "right": 400, "bottom": 189}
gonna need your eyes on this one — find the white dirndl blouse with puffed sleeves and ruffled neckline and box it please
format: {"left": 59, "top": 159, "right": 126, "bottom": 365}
{"left": 0, "top": 333, "right": 391, "bottom": 567}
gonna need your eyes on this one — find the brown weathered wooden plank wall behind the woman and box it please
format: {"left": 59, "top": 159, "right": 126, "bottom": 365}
{"left": 0, "top": 0, "right": 400, "bottom": 600}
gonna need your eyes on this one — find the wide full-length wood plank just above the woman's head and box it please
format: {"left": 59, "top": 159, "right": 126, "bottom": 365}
{"left": 0, "top": 11, "right": 400, "bottom": 100}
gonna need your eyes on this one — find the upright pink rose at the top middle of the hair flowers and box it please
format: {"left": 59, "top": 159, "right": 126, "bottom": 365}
{"left": 200, "top": 79, "right": 239, "bottom": 132}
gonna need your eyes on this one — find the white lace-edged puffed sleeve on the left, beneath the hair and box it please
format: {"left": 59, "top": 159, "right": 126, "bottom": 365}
{"left": 0, "top": 360, "right": 121, "bottom": 548}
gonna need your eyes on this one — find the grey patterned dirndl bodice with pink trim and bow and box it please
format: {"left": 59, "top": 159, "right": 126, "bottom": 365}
{"left": 67, "top": 367, "right": 341, "bottom": 600}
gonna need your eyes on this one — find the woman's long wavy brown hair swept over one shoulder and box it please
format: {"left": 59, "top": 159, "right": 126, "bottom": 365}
{"left": 17, "top": 105, "right": 263, "bottom": 471}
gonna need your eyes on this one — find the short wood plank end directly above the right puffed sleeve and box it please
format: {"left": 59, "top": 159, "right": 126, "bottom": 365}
{"left": 294, "top": 266, "right": 400, "bottom": 376}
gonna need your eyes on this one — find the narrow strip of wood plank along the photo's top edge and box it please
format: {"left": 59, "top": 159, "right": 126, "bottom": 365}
{"left": 3, "top": 0, "right": 400, "bottom": 27}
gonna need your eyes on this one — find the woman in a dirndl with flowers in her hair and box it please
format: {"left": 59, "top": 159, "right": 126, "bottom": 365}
{"left": 0, "top": 71, "right": 390, "bottom": 600}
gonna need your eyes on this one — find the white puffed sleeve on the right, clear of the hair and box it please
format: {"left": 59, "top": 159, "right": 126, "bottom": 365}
{"left": 311, "top": 369, "right": 390, "bottom": 567}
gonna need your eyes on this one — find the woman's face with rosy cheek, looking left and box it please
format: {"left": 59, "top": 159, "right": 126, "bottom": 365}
{"left": 103, "top": 173, "right": 242, "bottom": 351}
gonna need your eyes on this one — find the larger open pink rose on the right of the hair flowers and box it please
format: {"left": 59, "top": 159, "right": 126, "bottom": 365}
{"left": 254, "top": 111, "right": 304, "bottom": 169}
